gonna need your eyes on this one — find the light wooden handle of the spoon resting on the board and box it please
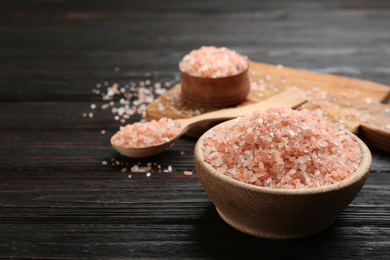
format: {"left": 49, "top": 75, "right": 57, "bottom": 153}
{"left": 175, "top": 87, "right": 307, "bottom": 131}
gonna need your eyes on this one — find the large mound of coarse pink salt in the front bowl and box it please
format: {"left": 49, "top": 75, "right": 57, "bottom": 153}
{"left": 202, "top": 108, "right": 362, "bottom": 189}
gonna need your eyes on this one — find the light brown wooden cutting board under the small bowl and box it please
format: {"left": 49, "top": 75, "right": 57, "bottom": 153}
{"left": 146, "top": 62, "right": 390, "bottom": 152}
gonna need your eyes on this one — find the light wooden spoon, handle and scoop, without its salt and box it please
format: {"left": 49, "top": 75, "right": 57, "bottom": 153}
{"left": 111, "top": 87, "right": 307, "bottom": 158}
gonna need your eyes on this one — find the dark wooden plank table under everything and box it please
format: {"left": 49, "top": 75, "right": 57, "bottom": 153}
{"left": 0, "top": 0, "right": 390, "bottom": 259}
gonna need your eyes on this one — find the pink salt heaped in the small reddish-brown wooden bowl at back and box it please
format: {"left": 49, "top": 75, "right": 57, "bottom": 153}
{"left": 179, "top": 46, "right": 248, "bottom": 78}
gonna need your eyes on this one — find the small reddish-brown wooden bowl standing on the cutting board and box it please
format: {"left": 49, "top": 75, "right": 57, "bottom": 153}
{"left": 181, "top": 62, "right": 250, "bottom": 108}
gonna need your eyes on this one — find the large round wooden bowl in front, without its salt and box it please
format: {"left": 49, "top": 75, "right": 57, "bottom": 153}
{"left": 195, "top": 122, "right": 372, "bottom": 239}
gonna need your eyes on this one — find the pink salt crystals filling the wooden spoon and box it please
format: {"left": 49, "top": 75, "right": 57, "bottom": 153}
{"left": 113, "top": 117, "right": 180, "bottom": 147}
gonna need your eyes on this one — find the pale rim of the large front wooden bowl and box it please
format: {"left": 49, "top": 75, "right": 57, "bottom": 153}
{"left": 194, "top": 119, "right": 372, "bottom": 195}
